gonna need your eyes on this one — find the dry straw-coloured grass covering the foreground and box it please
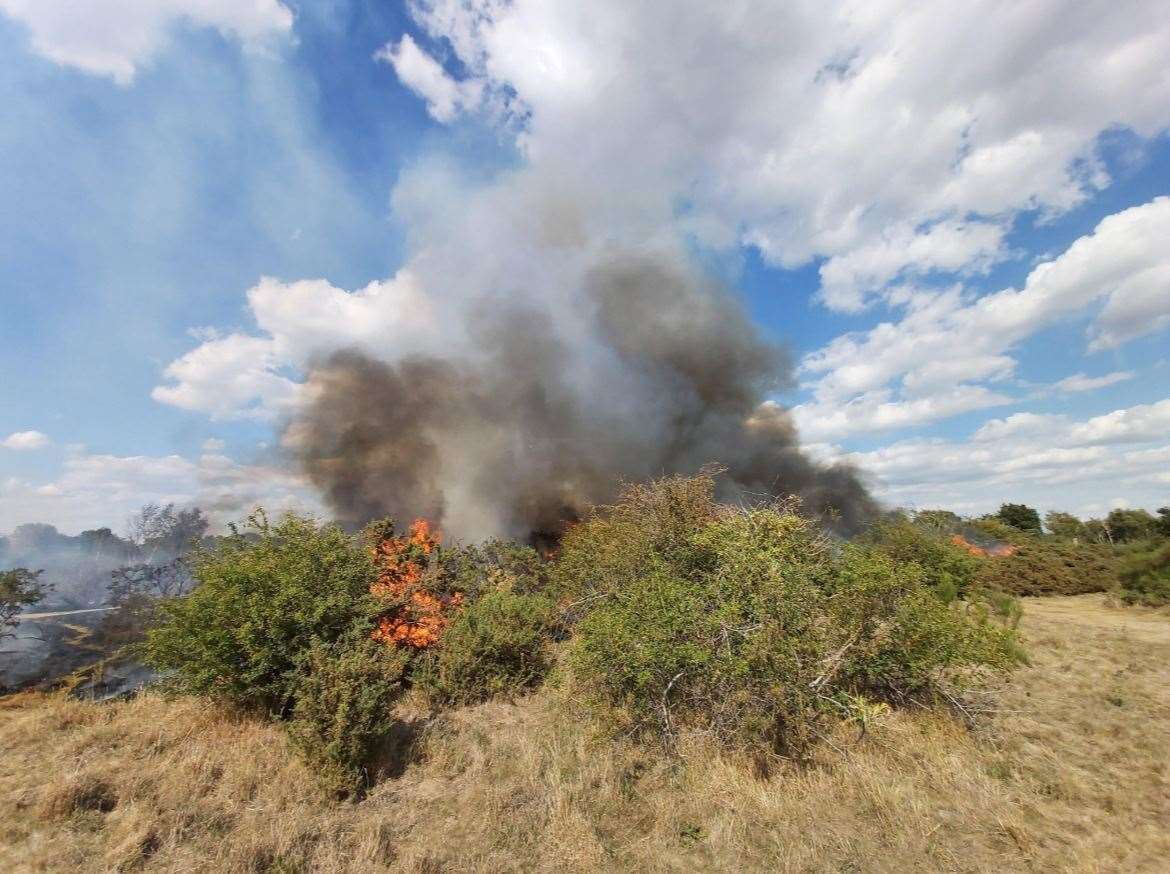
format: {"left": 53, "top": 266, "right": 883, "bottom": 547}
{"left": 0, "top": 596, "right": 1170, "bottom": 872}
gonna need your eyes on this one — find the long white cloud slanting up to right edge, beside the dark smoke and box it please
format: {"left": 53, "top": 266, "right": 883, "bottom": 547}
{"left": 798, "top": 197, "right": 1170, "bottom": 439}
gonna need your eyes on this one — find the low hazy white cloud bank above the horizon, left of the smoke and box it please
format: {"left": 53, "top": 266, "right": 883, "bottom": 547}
{"left": 0, "top": 452, "right": 323, "bottom": 532}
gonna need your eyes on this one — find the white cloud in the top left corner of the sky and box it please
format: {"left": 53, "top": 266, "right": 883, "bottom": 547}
{"left": 0, "top": 0, "right": 293, "bottom": 84}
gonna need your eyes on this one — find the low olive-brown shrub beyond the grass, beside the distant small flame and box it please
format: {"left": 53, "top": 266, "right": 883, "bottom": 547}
{"left": 976, "top": 538, "right": 1117, "bottom": 596}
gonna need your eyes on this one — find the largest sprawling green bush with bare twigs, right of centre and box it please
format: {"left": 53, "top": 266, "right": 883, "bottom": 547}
{"left": 560, "top": 480, "right": 1019, "bottom": 753}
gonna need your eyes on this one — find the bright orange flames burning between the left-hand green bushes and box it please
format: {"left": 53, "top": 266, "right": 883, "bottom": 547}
{"left": 370, "top": 519, "right": 463, "bottom": 649}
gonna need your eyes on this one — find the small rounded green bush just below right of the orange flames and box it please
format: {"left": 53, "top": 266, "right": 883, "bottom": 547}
{"left": 418, "top": 591, "right": 552, "bottom": 704}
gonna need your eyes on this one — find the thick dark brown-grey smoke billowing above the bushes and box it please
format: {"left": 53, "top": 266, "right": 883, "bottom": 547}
{"left": 284, "top": 252, "right": 873, "bottom": 538}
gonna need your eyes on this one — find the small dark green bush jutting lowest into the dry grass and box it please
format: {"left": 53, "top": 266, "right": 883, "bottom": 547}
{"left": 289, "top": 638, "right": 410, "bottom": 794}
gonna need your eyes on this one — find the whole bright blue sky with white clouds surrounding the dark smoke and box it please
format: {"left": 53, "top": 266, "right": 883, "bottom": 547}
{"left": 0, "top": 0, "right": 1170, "bottom": 531}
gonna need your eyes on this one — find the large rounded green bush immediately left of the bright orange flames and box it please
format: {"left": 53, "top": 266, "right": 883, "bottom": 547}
{"left": 143, "top": 515, "right": 376, "bottom": 715}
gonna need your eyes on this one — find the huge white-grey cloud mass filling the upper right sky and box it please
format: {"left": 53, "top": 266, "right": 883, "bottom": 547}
{"left": 393, "top": 0, "right": 1170, "bottom": 309}
